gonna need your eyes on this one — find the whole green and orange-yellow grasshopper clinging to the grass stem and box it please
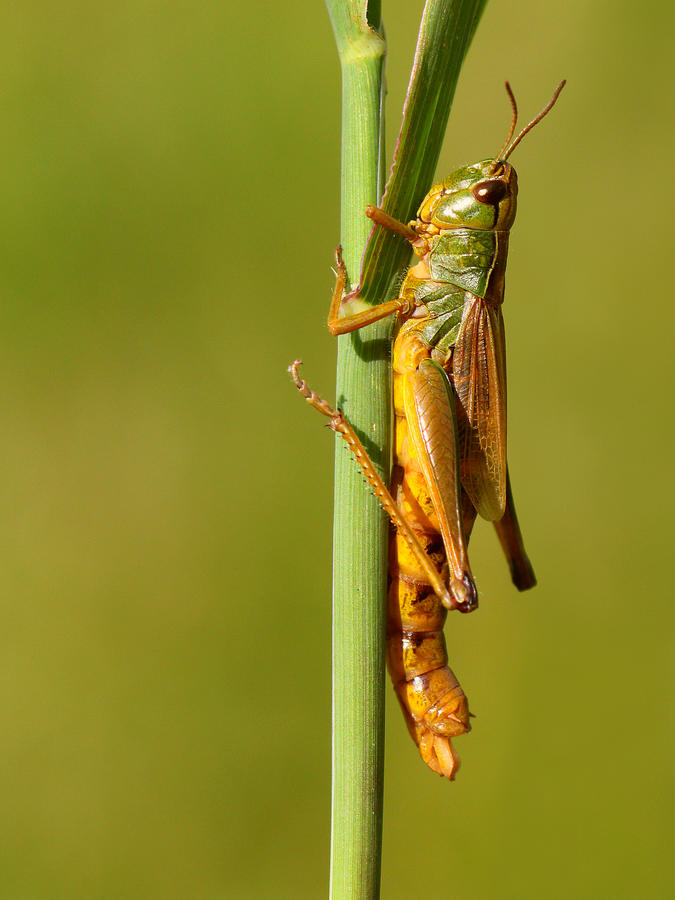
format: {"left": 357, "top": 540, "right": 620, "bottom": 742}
{"left": 290, "top": 81, "right": 565, "bottom": 779}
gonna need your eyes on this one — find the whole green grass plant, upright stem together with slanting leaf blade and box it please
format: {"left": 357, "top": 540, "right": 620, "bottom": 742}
{"left": 326, "top": 0, "right": 486, "bottom": 900}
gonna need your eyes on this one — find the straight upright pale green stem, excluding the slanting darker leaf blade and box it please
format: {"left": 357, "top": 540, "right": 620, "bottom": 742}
{"left": 328, "top": 0, "right": 391, "bottom": 900}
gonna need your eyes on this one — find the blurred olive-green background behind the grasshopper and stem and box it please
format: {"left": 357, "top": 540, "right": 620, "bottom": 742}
{"left": 0, "top": 0, "right": 675, "bottom": 900}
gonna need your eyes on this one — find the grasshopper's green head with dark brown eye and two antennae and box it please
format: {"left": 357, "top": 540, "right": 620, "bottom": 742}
{"left": 418, "top": 81, "right": 565, "bottom": 231}
